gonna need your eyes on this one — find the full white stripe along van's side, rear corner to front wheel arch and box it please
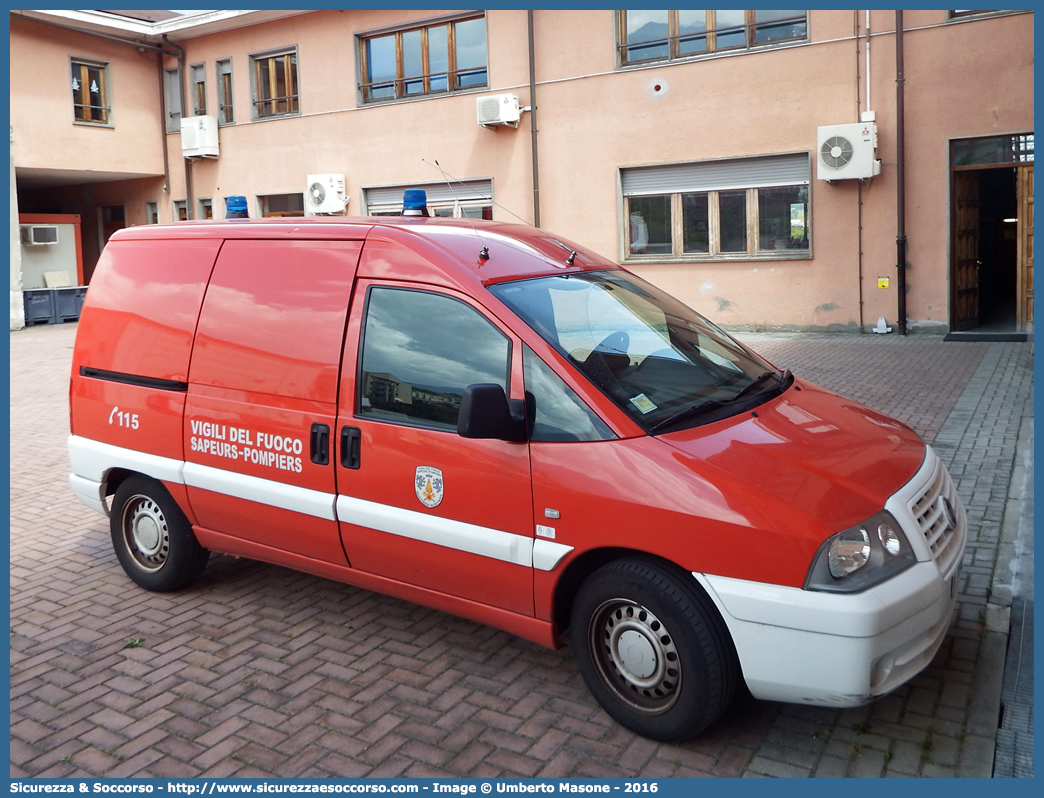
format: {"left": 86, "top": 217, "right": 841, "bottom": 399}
{"left": 69, "top": 436, "right": 573, "bottom": 571}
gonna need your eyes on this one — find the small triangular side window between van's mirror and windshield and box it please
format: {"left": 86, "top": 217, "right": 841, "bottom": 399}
{"left": 522, "top": 345, "right": 616, "bottom": 441}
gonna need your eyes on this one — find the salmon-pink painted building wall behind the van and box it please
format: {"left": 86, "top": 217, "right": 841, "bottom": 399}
{"left": 11, "top": 10, "right": 1034, "bottom": 328}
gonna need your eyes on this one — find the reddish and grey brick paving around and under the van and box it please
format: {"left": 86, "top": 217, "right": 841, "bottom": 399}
{"left": 10, "top": 325, "right": 1031, "bottom": 777}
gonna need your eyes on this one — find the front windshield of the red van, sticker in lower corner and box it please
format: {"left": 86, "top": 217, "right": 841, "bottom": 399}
{"left": 491, "top": 271, "right": 792, "bottom": 432}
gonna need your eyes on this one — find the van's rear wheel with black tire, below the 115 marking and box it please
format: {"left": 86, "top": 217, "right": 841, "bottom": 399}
{"left": 109, "top": 474, "right": 210, "bottom": 592}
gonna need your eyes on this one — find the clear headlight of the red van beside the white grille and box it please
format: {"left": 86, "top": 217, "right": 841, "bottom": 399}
{"left": 805, "top": 511, "right": 917, "bottom": 593}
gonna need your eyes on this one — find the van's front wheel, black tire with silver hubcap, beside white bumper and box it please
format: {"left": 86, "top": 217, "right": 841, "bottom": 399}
{"left": 570, "top": 559, "right": 739, "bottom": 742}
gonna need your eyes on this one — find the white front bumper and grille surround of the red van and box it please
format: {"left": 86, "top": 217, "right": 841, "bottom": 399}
{"left": 693, "top": 448, "right": 967, "bottom": 706}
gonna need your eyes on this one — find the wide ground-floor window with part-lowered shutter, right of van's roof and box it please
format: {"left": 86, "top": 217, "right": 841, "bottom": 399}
{"left": 620, "top": 154, "right": 810, "bottom": 261}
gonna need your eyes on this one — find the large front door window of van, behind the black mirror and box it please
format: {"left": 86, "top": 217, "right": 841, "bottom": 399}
{"left": 358, "top": 287, "right": 511, "bottom": 431}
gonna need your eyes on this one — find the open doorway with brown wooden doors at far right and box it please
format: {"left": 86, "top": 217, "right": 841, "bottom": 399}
{"left": 950, "top": 135, "right": 1034, "bottom": 341}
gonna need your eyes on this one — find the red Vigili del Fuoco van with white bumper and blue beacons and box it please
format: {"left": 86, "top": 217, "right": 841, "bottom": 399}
{"left": 69, "top": 200, "right": 966, "bottom": 740}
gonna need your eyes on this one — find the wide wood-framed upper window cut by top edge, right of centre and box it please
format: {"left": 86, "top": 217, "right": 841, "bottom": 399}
{"left": 617, "top": 9, "right": 808, "bottom": 65}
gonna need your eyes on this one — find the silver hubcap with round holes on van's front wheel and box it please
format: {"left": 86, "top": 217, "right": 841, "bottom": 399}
{"left": 591, "top": 599, "right": 682, "bottom": 713}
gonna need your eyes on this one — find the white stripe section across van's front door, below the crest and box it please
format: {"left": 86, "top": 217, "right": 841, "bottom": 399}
{"left": 337, "top": 495, "right": 532, "bottom": 566}
